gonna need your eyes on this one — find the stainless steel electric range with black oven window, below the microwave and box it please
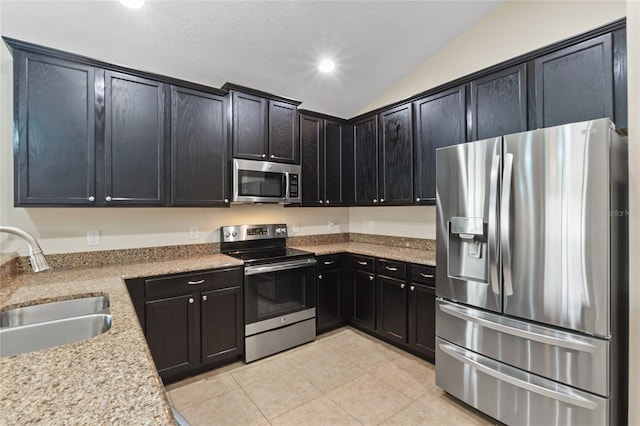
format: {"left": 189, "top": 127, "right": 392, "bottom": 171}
{"left": 220, "top": 224, "right": 316, "bottom": 362}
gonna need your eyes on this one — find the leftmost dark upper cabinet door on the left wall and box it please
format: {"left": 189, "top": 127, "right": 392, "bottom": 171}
{"left": 14, "top": 50, "right": 96, "bottom": 206}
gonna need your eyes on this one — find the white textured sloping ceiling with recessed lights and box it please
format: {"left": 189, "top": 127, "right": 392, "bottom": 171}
{"left": 0, "top": 0, "right": 502, "bottom": 118}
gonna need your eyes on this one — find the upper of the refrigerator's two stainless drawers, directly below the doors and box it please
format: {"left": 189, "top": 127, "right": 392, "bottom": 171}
{"left": 436, "top": 299, "right": 611, "bottom": 397}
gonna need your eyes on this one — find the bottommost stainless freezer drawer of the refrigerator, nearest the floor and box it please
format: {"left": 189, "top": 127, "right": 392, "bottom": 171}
{"left": 436, "top": 338, "right": 610, "bottom": 426}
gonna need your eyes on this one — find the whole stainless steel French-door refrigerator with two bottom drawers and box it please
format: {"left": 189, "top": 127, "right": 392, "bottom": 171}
{"left": 436, "top": 119, "right": 628, "bottom": 426}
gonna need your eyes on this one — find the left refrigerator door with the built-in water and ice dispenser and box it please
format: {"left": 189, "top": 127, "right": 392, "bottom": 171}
{"left": 436, "top": 138, "right": 502, "bottom": 311}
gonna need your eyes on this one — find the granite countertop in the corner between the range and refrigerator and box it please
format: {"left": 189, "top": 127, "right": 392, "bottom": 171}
{"left": 293, "top": 241, "right": 436, "bottom": 266}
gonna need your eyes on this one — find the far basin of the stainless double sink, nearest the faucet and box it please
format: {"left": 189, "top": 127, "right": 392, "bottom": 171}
{"left": 0, "top": 296, "right": 109, "bottom": 328}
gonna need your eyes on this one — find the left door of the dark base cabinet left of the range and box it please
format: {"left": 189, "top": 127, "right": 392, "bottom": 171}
{"left": 145, "top": 294, "right": 200, "bottom": 379}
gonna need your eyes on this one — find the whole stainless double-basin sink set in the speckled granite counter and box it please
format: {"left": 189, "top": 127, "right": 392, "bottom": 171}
{"left": 0, "top": 296, "right": 111, "bottom": 357}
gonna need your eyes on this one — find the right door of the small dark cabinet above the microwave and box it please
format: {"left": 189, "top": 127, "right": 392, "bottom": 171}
{"left": 269, "top": 101, "right": 300, "bottom": 164}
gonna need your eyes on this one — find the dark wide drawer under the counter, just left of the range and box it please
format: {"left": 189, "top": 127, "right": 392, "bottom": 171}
{"left": 144, "top": 268, "right": 242, "bottom": 299}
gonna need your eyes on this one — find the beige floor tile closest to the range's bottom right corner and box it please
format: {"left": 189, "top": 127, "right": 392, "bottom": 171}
{"left": 297, "top": 351, "right": 365, "bottom": 392}
